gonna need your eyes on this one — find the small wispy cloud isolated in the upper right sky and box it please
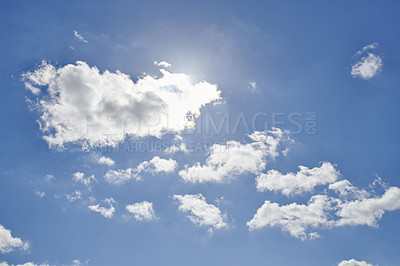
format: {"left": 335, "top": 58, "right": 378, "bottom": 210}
{"left": 351, "top": 43, "right": 383, "bottom": 79}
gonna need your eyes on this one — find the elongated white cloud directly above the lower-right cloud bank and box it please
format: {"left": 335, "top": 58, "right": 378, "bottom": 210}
{"left": 256, "top": 162, "right": 340, "bottom": 196}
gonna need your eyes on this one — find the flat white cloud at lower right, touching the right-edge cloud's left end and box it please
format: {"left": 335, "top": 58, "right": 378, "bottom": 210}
{"left": 247, "top": 195, "right": 334, "bottom": 240}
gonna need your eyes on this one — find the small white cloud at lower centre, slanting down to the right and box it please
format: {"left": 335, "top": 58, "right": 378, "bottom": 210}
{"left": 173, "top": 194, "right": 228, "bottom": 233}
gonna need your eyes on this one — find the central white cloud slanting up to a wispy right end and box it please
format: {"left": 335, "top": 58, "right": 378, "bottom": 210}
{"left": 179, "top": 128, "right": 290, "bottom": 183}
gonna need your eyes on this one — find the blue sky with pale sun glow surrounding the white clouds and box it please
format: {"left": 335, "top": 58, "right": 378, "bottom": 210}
{"left": 0, "top": 1, "right": 400, "bottom": 265}
